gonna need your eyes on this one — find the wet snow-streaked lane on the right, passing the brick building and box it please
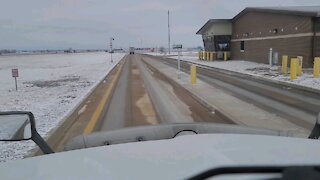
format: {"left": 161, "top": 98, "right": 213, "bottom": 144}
{"left": 151, "top": 55, "right": 320, "bottom": 132}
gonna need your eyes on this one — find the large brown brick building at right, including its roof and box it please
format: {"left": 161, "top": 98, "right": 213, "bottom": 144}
{"left": 198, "top": 6, "right": 320, "bottom": 67}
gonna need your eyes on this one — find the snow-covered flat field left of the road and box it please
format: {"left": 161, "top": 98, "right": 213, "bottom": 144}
{"left": 0, "top": 52, "right": 125, "bottom": 162}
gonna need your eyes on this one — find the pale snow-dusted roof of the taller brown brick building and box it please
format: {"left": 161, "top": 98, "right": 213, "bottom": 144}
{"left": 232, "top": 6, "right": 320, "bottom": 21}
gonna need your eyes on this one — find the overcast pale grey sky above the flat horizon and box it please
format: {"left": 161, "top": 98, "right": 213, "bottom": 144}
{"left": 0, "top": 0, "right": 320, "bottom": 49}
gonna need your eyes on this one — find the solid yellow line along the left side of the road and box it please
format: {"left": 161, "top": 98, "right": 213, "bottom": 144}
{"left": 83, "top": 63, "right": 123, "bottom": 134}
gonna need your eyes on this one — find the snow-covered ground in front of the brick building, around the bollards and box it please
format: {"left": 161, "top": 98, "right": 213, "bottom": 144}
{"left": 149, "top": 52, "right": 320, "bottom": 90}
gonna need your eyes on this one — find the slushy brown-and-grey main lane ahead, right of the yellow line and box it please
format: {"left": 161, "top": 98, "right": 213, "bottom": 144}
{"left": 100, "top": 55, "right": 224, "bottom": 131}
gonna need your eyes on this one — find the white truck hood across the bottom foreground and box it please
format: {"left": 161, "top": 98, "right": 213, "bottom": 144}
{"left": 0, "top": 134, "right": 320, "bottom": 180}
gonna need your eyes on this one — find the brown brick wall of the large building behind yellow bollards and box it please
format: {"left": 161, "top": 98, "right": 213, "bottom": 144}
{"left": 231, "top": 12, "right": 314, "bottom": 67}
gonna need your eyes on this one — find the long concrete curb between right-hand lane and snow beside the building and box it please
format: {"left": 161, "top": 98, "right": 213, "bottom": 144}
{"left": 167, "top": 58, "right": 320, "bottom": 95}
